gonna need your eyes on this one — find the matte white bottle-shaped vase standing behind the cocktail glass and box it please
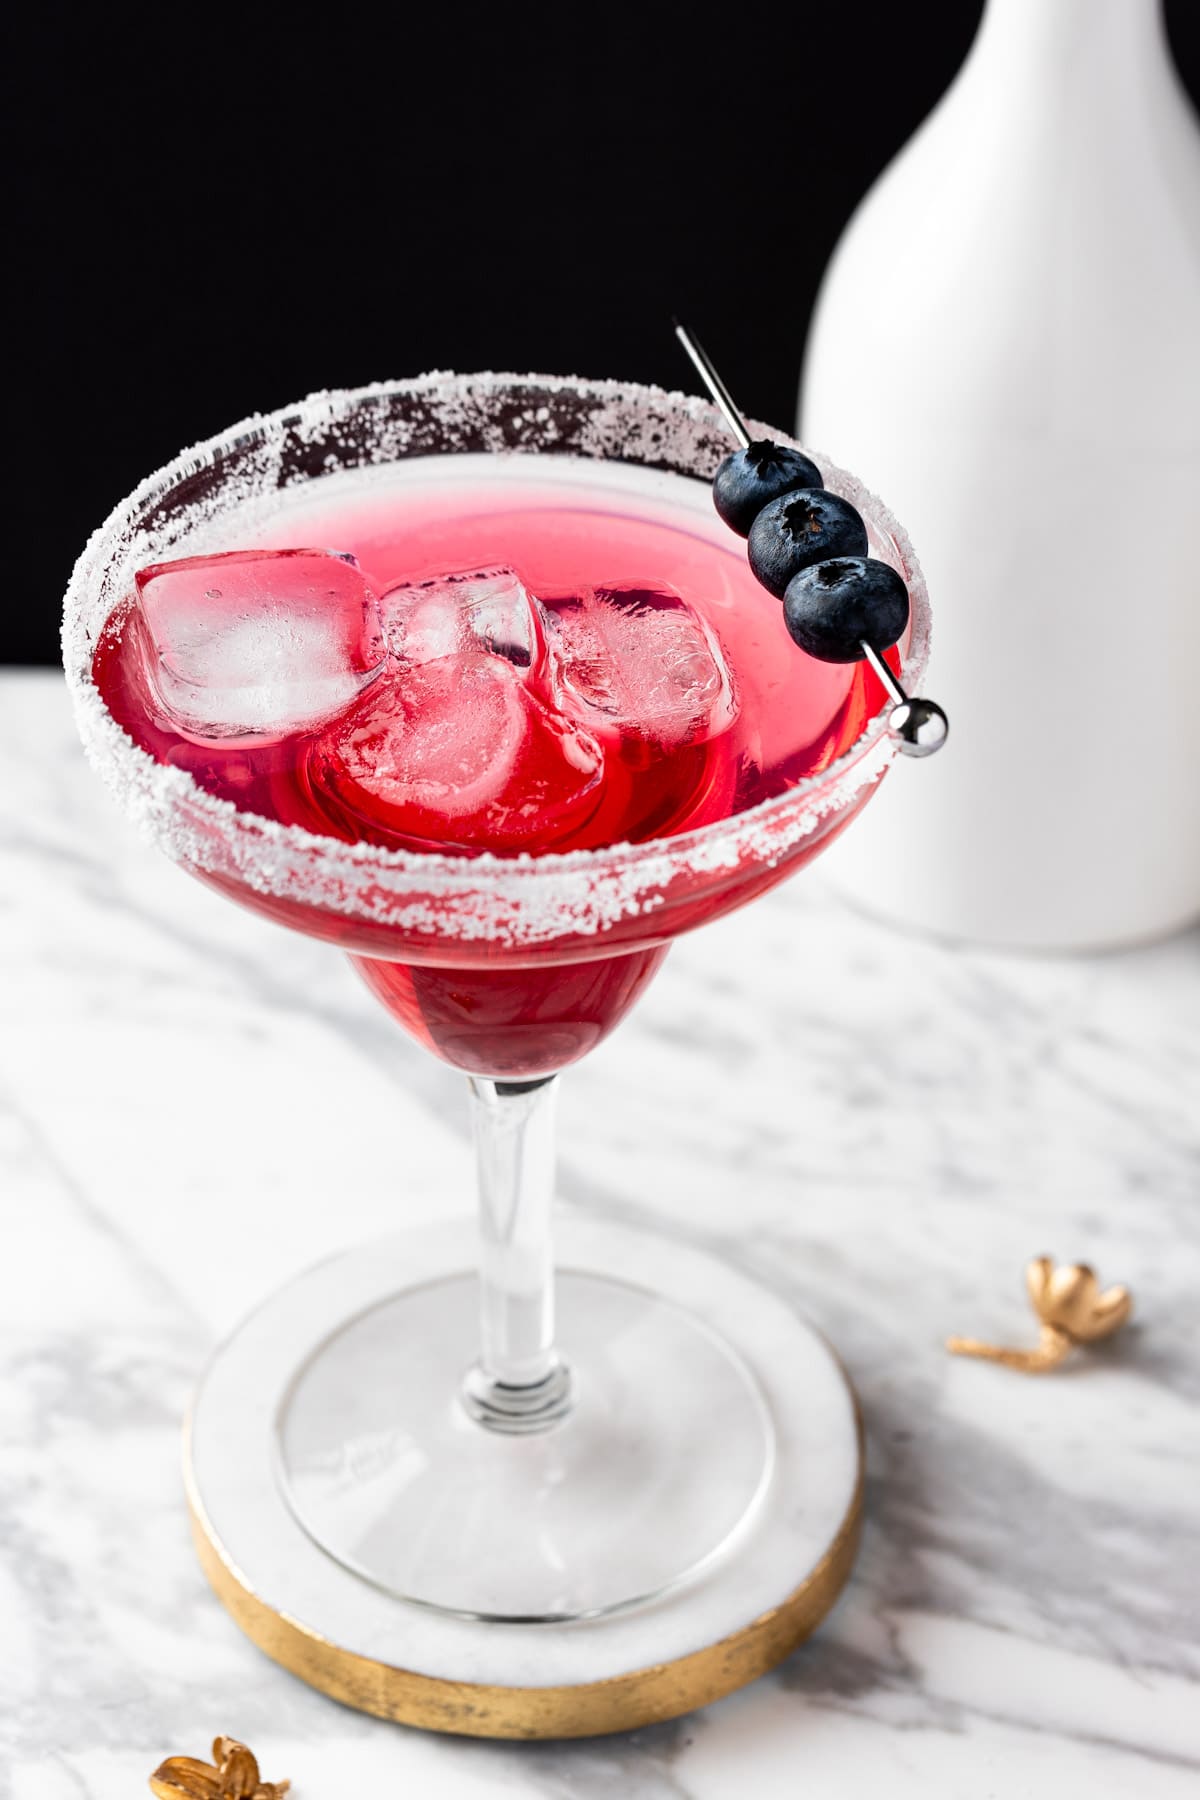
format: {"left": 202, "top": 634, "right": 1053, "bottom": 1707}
{"left": 799, "top": 0, "right": 1200, "bottom": 949}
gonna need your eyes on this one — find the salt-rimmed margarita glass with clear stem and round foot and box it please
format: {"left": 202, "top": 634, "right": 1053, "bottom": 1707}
{"left": 63, "top": 374, "right": 928, "bottom": 1648}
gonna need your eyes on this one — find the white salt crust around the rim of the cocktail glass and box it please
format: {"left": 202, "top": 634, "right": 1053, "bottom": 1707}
{"left": 63, "top": 371, "right": 930, "bottom": 950}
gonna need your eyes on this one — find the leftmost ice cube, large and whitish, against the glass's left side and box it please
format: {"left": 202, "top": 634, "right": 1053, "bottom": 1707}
{"left": 135, "top": 551, "right": 387, "bottom": 742}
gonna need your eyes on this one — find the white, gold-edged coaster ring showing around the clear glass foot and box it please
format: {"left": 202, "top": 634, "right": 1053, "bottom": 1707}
{"left": 185, "top": 1217, "right": 862, "bottom": 1739}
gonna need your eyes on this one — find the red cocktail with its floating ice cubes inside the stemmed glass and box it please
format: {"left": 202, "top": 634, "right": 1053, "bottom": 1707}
{"left": 94, "top": 455, "right": 900, "bottom": 1078}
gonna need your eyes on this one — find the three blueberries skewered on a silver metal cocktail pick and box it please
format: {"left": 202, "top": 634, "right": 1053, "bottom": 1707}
{"left": 675, "top": 319, "right": 950, "bottom": 756}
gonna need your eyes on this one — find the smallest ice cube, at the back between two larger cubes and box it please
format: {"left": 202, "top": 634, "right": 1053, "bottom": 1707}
{"left": 381, "top": 567, "right": 545, "bottom": 670}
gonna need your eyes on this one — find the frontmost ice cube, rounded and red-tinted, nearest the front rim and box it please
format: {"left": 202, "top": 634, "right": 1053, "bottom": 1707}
{"left": 313, "top": 652, "right": 604, "bottom": 851}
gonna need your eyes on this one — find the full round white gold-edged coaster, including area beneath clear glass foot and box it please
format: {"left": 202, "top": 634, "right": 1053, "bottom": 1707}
{"left": 187, "top": 1215, "right": 862, "bottom": 1737}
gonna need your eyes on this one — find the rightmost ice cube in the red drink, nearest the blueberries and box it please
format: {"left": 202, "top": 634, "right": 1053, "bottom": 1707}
{"left": 551, "top": 585, "right": 738, "bottom": 749}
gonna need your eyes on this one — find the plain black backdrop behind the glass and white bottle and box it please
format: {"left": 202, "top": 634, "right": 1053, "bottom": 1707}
{"left": 9, "top": 0, "right": 1200, "bottom": 662}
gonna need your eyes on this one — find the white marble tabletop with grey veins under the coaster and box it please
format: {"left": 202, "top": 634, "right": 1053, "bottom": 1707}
{"left": 0, "top": 673, "right": 1200, "bottom": 1800}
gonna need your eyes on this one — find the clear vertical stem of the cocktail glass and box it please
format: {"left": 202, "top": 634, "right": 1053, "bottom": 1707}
{"left": 462, "top": 1075, "right": 570, "bottom": 1433}
